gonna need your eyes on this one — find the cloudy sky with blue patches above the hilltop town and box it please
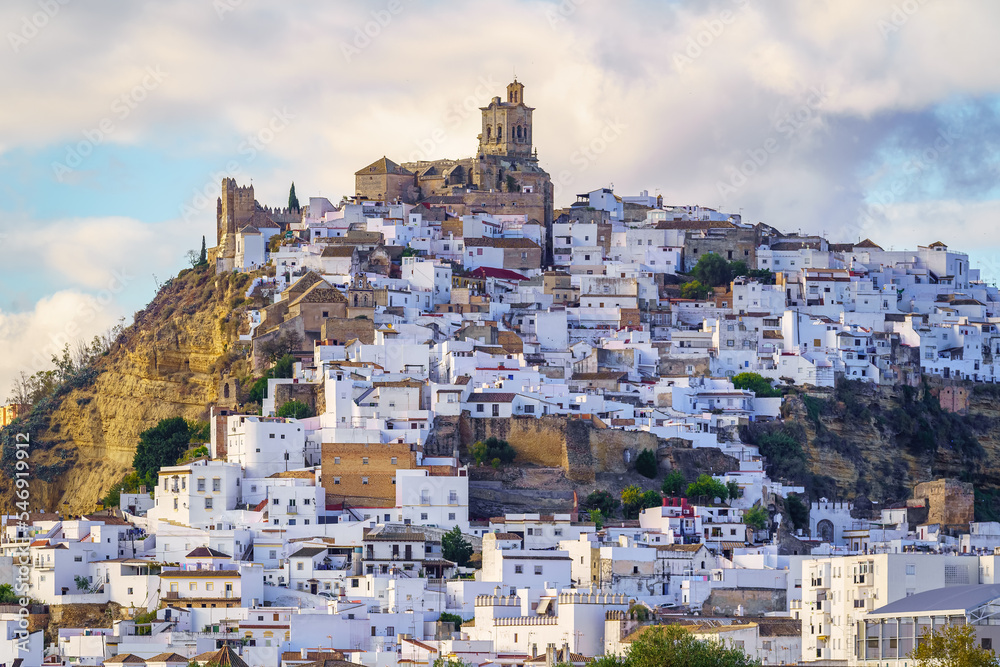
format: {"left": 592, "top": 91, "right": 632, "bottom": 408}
{"left": 0, "top": 0, "right": 1000, "bottom": 397}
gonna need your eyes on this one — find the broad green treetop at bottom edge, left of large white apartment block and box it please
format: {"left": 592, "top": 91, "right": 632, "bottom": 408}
{"left": 590, "top": 625, "right": 760, "bottom": 667}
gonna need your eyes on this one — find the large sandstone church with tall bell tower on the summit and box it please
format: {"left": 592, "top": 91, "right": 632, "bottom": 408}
{"left": 354, "top": 79, "right": 553, "bottom": 227}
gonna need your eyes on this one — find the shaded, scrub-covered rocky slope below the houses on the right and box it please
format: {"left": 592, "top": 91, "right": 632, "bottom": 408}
{"left": 743, "top": 382, "right": 1000, "bottom": 516}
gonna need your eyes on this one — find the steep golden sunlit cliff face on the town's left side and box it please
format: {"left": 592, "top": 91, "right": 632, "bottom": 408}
{"left": 0, "top": 269, "right": 249, "bottom": 514}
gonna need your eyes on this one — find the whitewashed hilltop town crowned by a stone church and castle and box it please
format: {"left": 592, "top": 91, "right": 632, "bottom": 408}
{"left": 0, "top": 81, "right": 1000, "bottom": 667}
